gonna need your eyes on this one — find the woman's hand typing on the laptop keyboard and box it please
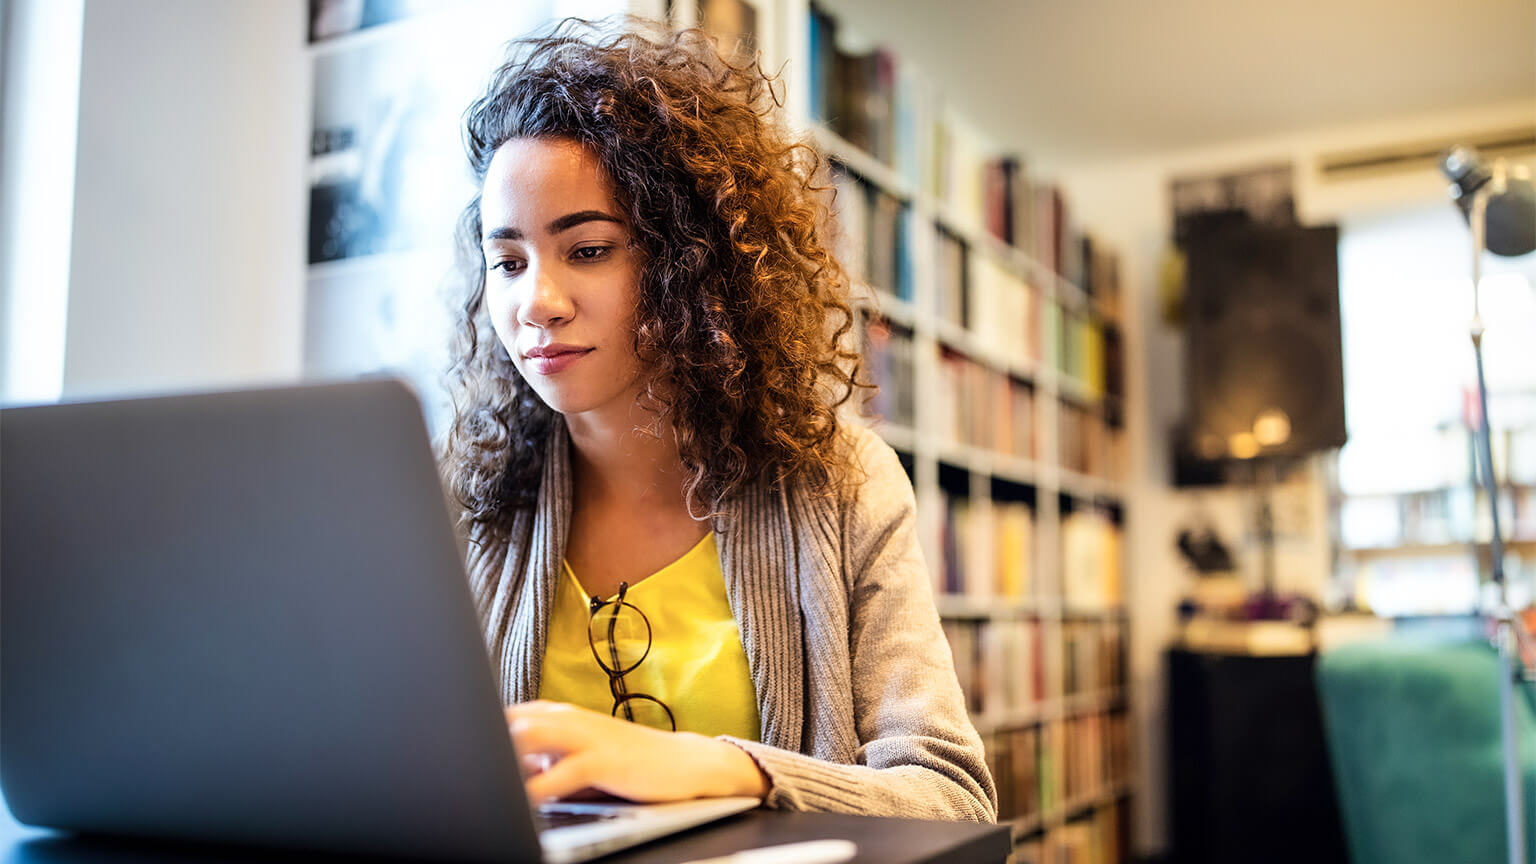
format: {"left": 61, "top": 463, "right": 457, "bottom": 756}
{"left": 507, "top": 701, "right": 768, "bottom": 806}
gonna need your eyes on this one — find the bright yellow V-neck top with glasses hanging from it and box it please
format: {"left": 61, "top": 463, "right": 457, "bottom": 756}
{"left": 539, "top": 532, "right": 759, "bottom": 741}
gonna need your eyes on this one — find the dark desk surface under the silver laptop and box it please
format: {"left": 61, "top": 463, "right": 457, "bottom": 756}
{"left": 0, "top": 807, "right": 1011, "bottom": 864}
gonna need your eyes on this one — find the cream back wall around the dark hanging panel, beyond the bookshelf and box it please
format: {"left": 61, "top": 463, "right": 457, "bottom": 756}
{"left": 1048, "top": 103, "right": 1536, "bottom": 852}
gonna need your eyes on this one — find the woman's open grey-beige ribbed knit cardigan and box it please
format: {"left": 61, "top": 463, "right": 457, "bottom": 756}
{"left": 468, "top": 423, "right": 997, "bottom": 821}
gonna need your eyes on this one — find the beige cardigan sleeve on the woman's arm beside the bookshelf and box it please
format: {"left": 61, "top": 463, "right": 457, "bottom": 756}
{"left": 728, "top": 430, "right": 997, "bottom": 822}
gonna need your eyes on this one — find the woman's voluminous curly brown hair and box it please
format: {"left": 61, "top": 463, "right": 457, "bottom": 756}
{"left": 444, "top": 18, "right": 868, "bottom": 537}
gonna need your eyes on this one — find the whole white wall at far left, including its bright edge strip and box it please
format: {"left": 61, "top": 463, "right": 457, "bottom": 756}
{"left": 0, "top": 0, "right": 310, "bottom": 401}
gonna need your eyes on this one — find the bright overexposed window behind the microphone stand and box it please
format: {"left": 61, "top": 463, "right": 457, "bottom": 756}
{"left": 1338, "top": 203, "right": 1536, "bottom": 615}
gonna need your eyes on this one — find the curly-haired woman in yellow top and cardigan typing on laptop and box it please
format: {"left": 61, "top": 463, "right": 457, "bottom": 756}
{"left": 445, "top": 16, "right": 997, "bottom": 821}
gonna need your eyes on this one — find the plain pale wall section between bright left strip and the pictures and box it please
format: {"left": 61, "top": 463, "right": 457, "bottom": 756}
{"left": 63, "top": 0, "right": 309, "bottom": 397}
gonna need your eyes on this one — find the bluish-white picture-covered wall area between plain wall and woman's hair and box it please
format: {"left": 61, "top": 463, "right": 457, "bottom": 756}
{"left": 304, "top": 2, "right": 556, "bottom": 435}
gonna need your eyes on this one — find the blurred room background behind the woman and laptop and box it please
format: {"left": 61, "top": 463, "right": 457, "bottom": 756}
{"left": 0, "top": 0, "right": 1536, "bottom": 862}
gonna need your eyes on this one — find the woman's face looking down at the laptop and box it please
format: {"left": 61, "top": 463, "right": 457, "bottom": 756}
{"left": 481, "top": 138, "right": 642, "bottom": 423}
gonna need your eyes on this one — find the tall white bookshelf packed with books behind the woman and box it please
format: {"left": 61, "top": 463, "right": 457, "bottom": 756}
{"left": 771, "top": 0, "right": 1132, "bottom": 862}
